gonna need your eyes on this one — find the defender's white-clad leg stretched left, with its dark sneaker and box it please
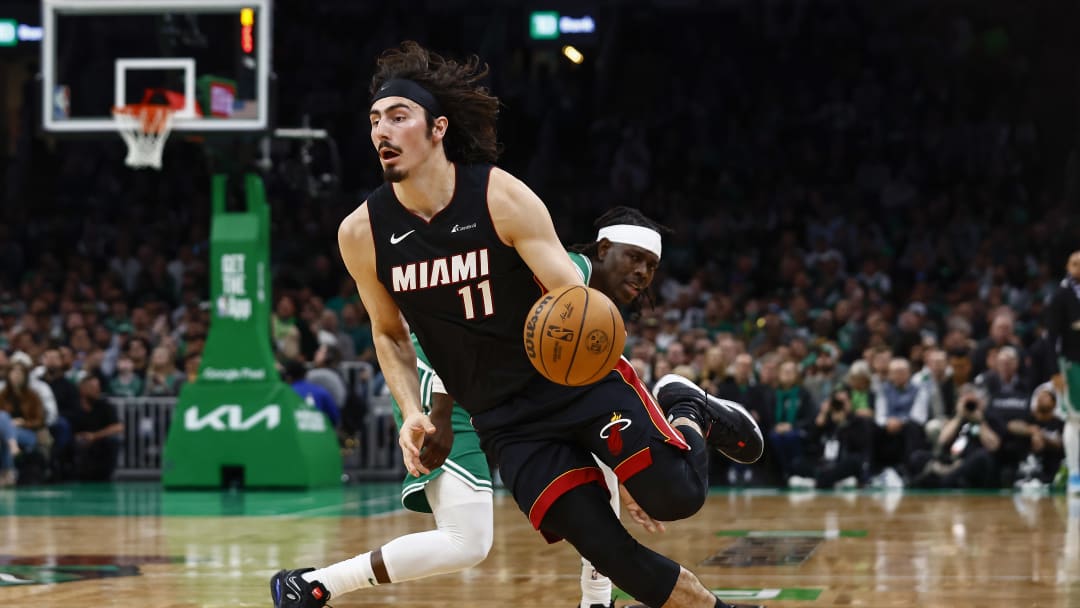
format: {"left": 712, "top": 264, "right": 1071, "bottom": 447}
{"left": 270, "top": 473, "right": 494, "bottom": 608}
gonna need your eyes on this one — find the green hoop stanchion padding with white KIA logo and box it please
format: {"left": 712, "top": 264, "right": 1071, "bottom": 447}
{"left": 162, "top": 175, "right": 341, "bottom": 488}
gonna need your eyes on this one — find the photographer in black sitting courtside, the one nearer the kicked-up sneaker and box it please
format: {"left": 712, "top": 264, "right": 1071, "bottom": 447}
{"left": 788, "top": 384, "right": 874, "bottom": 489}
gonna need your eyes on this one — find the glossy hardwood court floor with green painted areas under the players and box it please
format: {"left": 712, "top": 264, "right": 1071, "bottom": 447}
{"left": 0, "top": 484, "right": 1080, "bottom": 608}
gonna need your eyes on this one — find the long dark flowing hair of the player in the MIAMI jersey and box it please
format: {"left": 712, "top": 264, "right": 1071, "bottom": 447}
{"left": 369, "top": 40, "right": 502, "bottom": 164}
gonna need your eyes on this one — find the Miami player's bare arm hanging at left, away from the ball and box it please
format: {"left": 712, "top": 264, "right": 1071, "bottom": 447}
{"left": 338, "top": 202, "right": 435, "bottom": 476}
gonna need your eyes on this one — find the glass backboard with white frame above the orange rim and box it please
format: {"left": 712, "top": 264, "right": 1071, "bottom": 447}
{"left": 41, "top": 0, "right": 272, "bottom": 134}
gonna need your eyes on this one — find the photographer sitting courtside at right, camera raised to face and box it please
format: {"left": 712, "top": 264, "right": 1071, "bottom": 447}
{"left": 913, "top": 384, "right": 1001, "bottom": 488}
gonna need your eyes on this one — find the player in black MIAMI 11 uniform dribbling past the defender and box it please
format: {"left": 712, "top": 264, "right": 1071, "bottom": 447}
{"left": 271, "top": 43, "right": 756, "bottom": 608}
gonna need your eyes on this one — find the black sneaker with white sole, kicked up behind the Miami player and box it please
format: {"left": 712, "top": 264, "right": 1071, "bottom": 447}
{"left": 652, "top": 374, "right": 765, "bottom": 464}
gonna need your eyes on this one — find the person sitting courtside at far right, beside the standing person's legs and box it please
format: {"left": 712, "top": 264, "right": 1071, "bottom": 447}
{"left": 1007, "top": 384, "right": 1065, "bottom": 486}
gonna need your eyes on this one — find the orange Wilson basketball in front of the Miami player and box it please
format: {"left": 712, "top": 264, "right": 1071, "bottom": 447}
{"left": 524, "top": 285, "right": 626, "bottom": 387}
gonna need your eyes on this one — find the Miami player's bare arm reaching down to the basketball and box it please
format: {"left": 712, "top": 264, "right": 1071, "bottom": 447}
{"left": 487, "top": 168, "right": 584, "bottom": 289}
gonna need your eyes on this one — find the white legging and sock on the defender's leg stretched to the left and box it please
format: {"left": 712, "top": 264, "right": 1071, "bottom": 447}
{"left": 303, "top": 472, "right": 495, "bottom": 597}
